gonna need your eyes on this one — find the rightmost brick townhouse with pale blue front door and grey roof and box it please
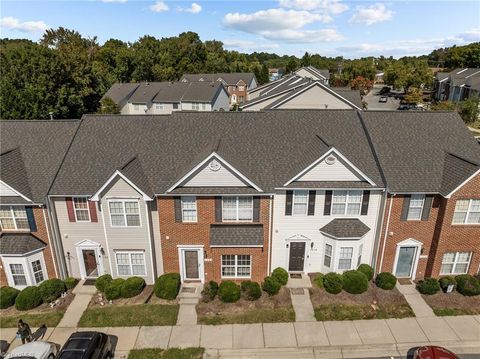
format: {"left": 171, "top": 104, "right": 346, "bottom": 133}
{"left": 365, "top": 111, "right": 480, "bottom": 279}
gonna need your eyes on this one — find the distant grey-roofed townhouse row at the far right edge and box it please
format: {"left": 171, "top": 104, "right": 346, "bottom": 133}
{"left": 432, "top": 68, "right": 480, "bottom": 102}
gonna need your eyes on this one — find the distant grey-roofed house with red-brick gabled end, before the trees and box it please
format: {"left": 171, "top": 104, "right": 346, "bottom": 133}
{"left": 180, "top": 72, "right": 257, "bottom": 106}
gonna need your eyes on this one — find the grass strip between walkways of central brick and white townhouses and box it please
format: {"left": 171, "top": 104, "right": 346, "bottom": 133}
{"left": 198, "top": 307, "right": 295, "bottom": 325}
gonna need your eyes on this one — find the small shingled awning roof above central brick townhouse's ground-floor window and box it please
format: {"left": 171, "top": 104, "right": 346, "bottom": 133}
{"left": 210, "top": 224, "right": 263, "bottom": 246}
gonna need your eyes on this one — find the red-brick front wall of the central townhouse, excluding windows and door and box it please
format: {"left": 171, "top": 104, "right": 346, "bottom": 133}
{"left": 157, "top": 197, "right": 270, "bottom": 282}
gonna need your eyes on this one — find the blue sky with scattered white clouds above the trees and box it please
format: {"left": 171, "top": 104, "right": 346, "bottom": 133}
{"left": 0, "top": 0, "right": 480, "bottom": 58}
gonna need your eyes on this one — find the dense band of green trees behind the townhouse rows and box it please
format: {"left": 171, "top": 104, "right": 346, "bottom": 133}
{"left": 0, "top": 28, "right": 480, "bottom": 119}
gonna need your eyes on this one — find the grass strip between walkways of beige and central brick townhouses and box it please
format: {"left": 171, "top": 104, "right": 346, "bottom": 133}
{"left": 78, "top": 304, "right": 179, "bottom": 327}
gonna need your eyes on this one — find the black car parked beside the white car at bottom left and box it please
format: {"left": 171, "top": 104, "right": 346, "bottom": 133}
{"left": 57, "top": 332, "right": 113, "bottom": 359}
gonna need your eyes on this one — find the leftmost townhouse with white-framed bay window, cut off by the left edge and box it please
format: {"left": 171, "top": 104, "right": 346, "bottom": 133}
{"left": 0, "top": 121, "right": 79, "bottom": 289}
